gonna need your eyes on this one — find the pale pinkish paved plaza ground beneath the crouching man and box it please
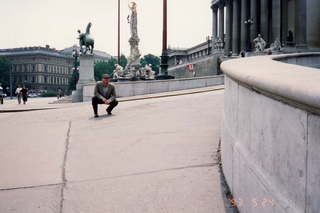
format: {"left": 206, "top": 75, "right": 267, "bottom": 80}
{"left": 0, "top": 90, "right": 227, "bottom": 213}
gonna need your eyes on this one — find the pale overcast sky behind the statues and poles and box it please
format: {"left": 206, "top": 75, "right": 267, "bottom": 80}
{"left": 0, "top": 0, "right": 212, "bottom": 55}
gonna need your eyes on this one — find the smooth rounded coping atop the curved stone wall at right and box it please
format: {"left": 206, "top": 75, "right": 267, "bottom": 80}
{"left": 221, "top": 52, "right": 320, "bottom": 109}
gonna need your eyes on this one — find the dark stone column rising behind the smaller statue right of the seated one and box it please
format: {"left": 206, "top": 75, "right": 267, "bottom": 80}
{"left": 270, "top": 0, "right": 281, "bottom": 43}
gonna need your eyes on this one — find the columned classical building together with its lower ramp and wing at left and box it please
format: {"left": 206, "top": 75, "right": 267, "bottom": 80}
{"left": 168, "top": 0, "right": 320, "bottom": 78}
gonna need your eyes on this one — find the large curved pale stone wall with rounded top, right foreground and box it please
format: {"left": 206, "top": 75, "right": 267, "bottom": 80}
{"left": 221, "top": 53, "right": 320, "bottom": 213}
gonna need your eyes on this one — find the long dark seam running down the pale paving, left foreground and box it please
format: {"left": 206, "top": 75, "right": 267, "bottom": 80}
{"left": 60, "top": 120, "right": 72, "bottom": 213}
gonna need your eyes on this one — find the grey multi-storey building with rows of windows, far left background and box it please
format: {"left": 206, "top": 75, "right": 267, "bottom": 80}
{"left": 0, "top": 46, "right": 74, "bottom": 91}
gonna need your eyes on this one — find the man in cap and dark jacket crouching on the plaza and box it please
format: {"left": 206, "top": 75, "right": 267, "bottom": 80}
{"left": 92, "top": 74, "right": 118, "bottom": 118}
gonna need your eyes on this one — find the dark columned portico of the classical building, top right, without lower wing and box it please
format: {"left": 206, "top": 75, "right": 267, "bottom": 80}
{"left": 211, "top": 0, "right": 320, "bottom": 55}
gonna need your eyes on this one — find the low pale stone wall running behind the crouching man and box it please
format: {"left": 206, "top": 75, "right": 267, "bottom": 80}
{"left": 83, "top": 75, "right": 224, "bottom": 101}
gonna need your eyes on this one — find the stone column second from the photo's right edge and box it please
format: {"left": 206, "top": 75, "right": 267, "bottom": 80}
{"left": 295, "top": 0, "right": 307, "bottom": 47}
